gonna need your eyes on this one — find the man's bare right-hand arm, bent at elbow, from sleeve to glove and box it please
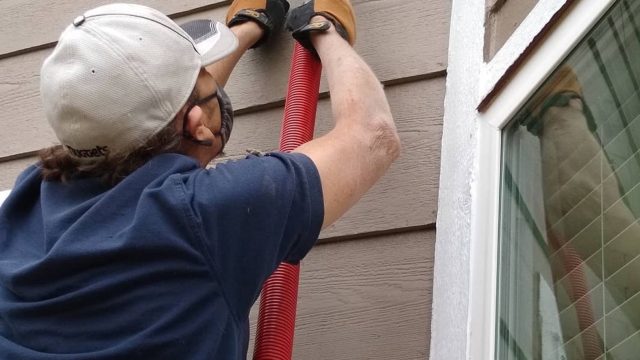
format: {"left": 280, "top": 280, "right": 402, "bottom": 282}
{"left": 295, "top": 18, "right": 400, "bottom": 228}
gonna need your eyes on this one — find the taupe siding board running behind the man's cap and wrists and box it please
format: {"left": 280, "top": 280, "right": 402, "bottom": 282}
{"left": 0, "top": 0, "right": 448, "bottom": 159}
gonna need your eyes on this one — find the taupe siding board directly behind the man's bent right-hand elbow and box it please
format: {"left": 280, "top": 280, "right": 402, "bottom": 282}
{"left": 0, "top": 78, "right": 445, "bottom": 239}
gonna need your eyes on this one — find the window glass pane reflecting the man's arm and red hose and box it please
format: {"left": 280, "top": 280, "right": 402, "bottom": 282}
{"left": 496, "top": 0, "right": 640, "bottom": 360}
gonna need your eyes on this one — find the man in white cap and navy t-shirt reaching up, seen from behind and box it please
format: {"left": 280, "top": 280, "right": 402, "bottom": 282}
{"left": 0, "top": 0, "right": 399, "bottom": 359}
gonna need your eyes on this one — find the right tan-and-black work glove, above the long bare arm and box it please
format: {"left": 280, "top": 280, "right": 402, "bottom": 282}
{"left": 287, "top": 0, "right": 356, "bottom": 55}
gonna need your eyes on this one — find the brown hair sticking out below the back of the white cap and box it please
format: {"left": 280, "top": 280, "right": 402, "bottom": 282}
{"left": 39, "top": 121, "right": 181, "bottom": 186}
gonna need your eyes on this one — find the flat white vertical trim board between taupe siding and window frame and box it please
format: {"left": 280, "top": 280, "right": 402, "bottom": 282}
{"left": 430, "top": 0, "right": 485, "bottom": 360}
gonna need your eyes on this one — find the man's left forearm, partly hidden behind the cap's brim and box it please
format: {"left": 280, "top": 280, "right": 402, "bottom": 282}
{"left": 205, "top": 21, "right": 263, "bottom": 86}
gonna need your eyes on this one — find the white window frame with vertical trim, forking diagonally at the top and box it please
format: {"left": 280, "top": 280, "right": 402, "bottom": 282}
{"left": 430, "top": 0, "right": 615, "bottom": 360}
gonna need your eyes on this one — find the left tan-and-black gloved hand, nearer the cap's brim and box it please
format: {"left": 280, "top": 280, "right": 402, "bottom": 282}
{"left": 227, "top": 0, "right": 289, "bottom": 48}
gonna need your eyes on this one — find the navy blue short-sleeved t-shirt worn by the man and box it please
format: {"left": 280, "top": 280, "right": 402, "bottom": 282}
{"left": 0, "top": 153, "right": 324, "bottom": 360}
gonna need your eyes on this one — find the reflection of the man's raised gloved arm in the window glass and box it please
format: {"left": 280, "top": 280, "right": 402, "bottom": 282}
{"left": 525, "top": 64, "right": 640, "bottom": 360}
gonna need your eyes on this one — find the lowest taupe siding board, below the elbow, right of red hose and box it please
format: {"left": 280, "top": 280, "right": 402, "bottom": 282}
{"left": 249, "top": 230, "right": 435, "bottom": 360}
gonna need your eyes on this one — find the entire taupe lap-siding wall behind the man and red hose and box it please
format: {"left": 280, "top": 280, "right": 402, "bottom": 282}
{"left": 0, "top": 0, "right": 450, "bottom": 359}
